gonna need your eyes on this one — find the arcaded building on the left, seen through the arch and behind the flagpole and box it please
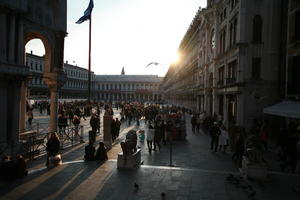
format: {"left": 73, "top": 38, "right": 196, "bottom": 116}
{"left": 26, "top": 52, "right": 95, "bottom": 99}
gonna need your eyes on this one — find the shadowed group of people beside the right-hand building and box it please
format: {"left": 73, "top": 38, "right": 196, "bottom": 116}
{"left": 190, "top": 112, "right": 300, "bottom": 172}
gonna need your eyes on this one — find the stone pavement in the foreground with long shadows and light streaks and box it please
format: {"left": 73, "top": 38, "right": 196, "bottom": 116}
{"left": 0, "top": 115, "right": 300, "bottom": 200}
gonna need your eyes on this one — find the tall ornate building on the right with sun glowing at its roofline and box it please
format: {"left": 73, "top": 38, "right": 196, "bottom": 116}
{"left": 162, "top": 0, "right": 284, "bottom": 129}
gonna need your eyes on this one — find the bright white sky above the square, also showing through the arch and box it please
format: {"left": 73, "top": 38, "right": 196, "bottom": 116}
{"left": 26, "top": 0, "right": 206, "bottom": 76}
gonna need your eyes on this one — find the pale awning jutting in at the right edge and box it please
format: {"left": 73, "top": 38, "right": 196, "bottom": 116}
{"left": 264, "top": 101, "right": 300, "bottom": 119}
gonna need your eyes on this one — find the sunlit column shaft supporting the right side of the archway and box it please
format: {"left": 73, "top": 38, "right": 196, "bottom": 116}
{"left": 49, "top": 84, "right": 58, "bottom": 133}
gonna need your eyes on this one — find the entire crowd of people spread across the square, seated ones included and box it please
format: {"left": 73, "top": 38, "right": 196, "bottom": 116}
{"left": 2, "top": 99, "right": 300, "bottom": 180}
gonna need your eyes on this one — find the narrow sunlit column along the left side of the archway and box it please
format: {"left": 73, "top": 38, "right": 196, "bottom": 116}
{"left": 19, "top": 80, "right": 27, "bottom": 133}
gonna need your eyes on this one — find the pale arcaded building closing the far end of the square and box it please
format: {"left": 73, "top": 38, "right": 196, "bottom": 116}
{"left": 95, "top": 69, "right": 162, "bottom": 102}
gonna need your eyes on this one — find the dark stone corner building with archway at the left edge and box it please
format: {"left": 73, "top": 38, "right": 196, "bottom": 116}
{"left": 0, "top": 0, "right": 67, "bottom": 154}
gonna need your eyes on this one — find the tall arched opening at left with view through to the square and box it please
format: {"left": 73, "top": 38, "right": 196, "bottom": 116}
{"left": 19, "top": 33, "right": 51, "bottom": 132}
